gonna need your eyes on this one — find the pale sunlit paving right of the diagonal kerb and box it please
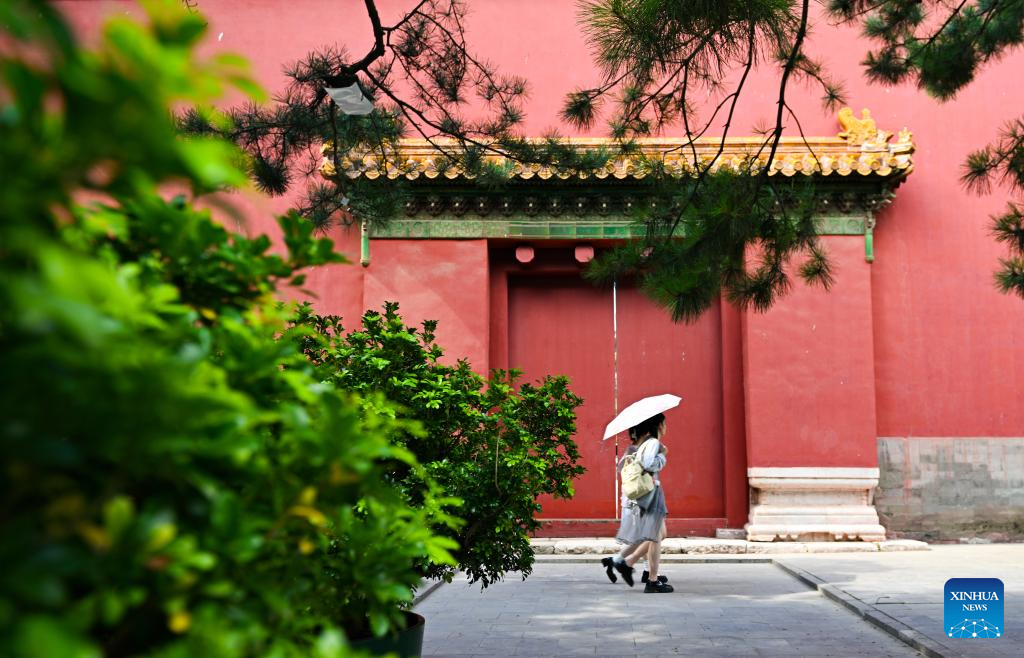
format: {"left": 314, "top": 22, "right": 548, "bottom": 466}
{"left": 778, "top": 543, "right": 1024, "bottom": 657}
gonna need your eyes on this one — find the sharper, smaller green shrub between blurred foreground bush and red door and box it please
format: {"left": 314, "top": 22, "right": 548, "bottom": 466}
{"left": 298, "top": 303, "right": 584, "bottom": 586}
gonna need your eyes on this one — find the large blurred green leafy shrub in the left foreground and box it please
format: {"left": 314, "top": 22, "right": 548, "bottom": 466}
{"left": 0, "top": 0, "right": 456, "bottom": 658}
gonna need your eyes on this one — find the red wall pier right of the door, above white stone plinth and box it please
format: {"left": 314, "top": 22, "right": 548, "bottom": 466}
{"left": 743, "top": 235, "right": 878, "bottom": 467}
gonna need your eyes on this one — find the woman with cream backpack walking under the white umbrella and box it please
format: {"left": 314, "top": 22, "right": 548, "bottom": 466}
{"left": 601, "top": 413, "right": 673, "bottom": 594}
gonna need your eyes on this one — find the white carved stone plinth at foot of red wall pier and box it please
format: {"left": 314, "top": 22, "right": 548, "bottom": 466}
{"left": 746, "top": 468, "right": 886, "bottom": 541}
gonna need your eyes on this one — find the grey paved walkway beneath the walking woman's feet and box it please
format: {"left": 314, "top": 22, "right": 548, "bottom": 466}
{"left": 417, "top": 561, "right": 919, "bottom": 657}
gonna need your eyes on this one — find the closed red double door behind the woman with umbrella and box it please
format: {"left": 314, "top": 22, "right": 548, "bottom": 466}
{"left": 509, "top": 275, "right": 725, "bottom": 534}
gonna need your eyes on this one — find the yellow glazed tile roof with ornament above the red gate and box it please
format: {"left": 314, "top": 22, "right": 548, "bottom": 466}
{"left": 319, "top": 107, "right": 914, "bottom": 180}
